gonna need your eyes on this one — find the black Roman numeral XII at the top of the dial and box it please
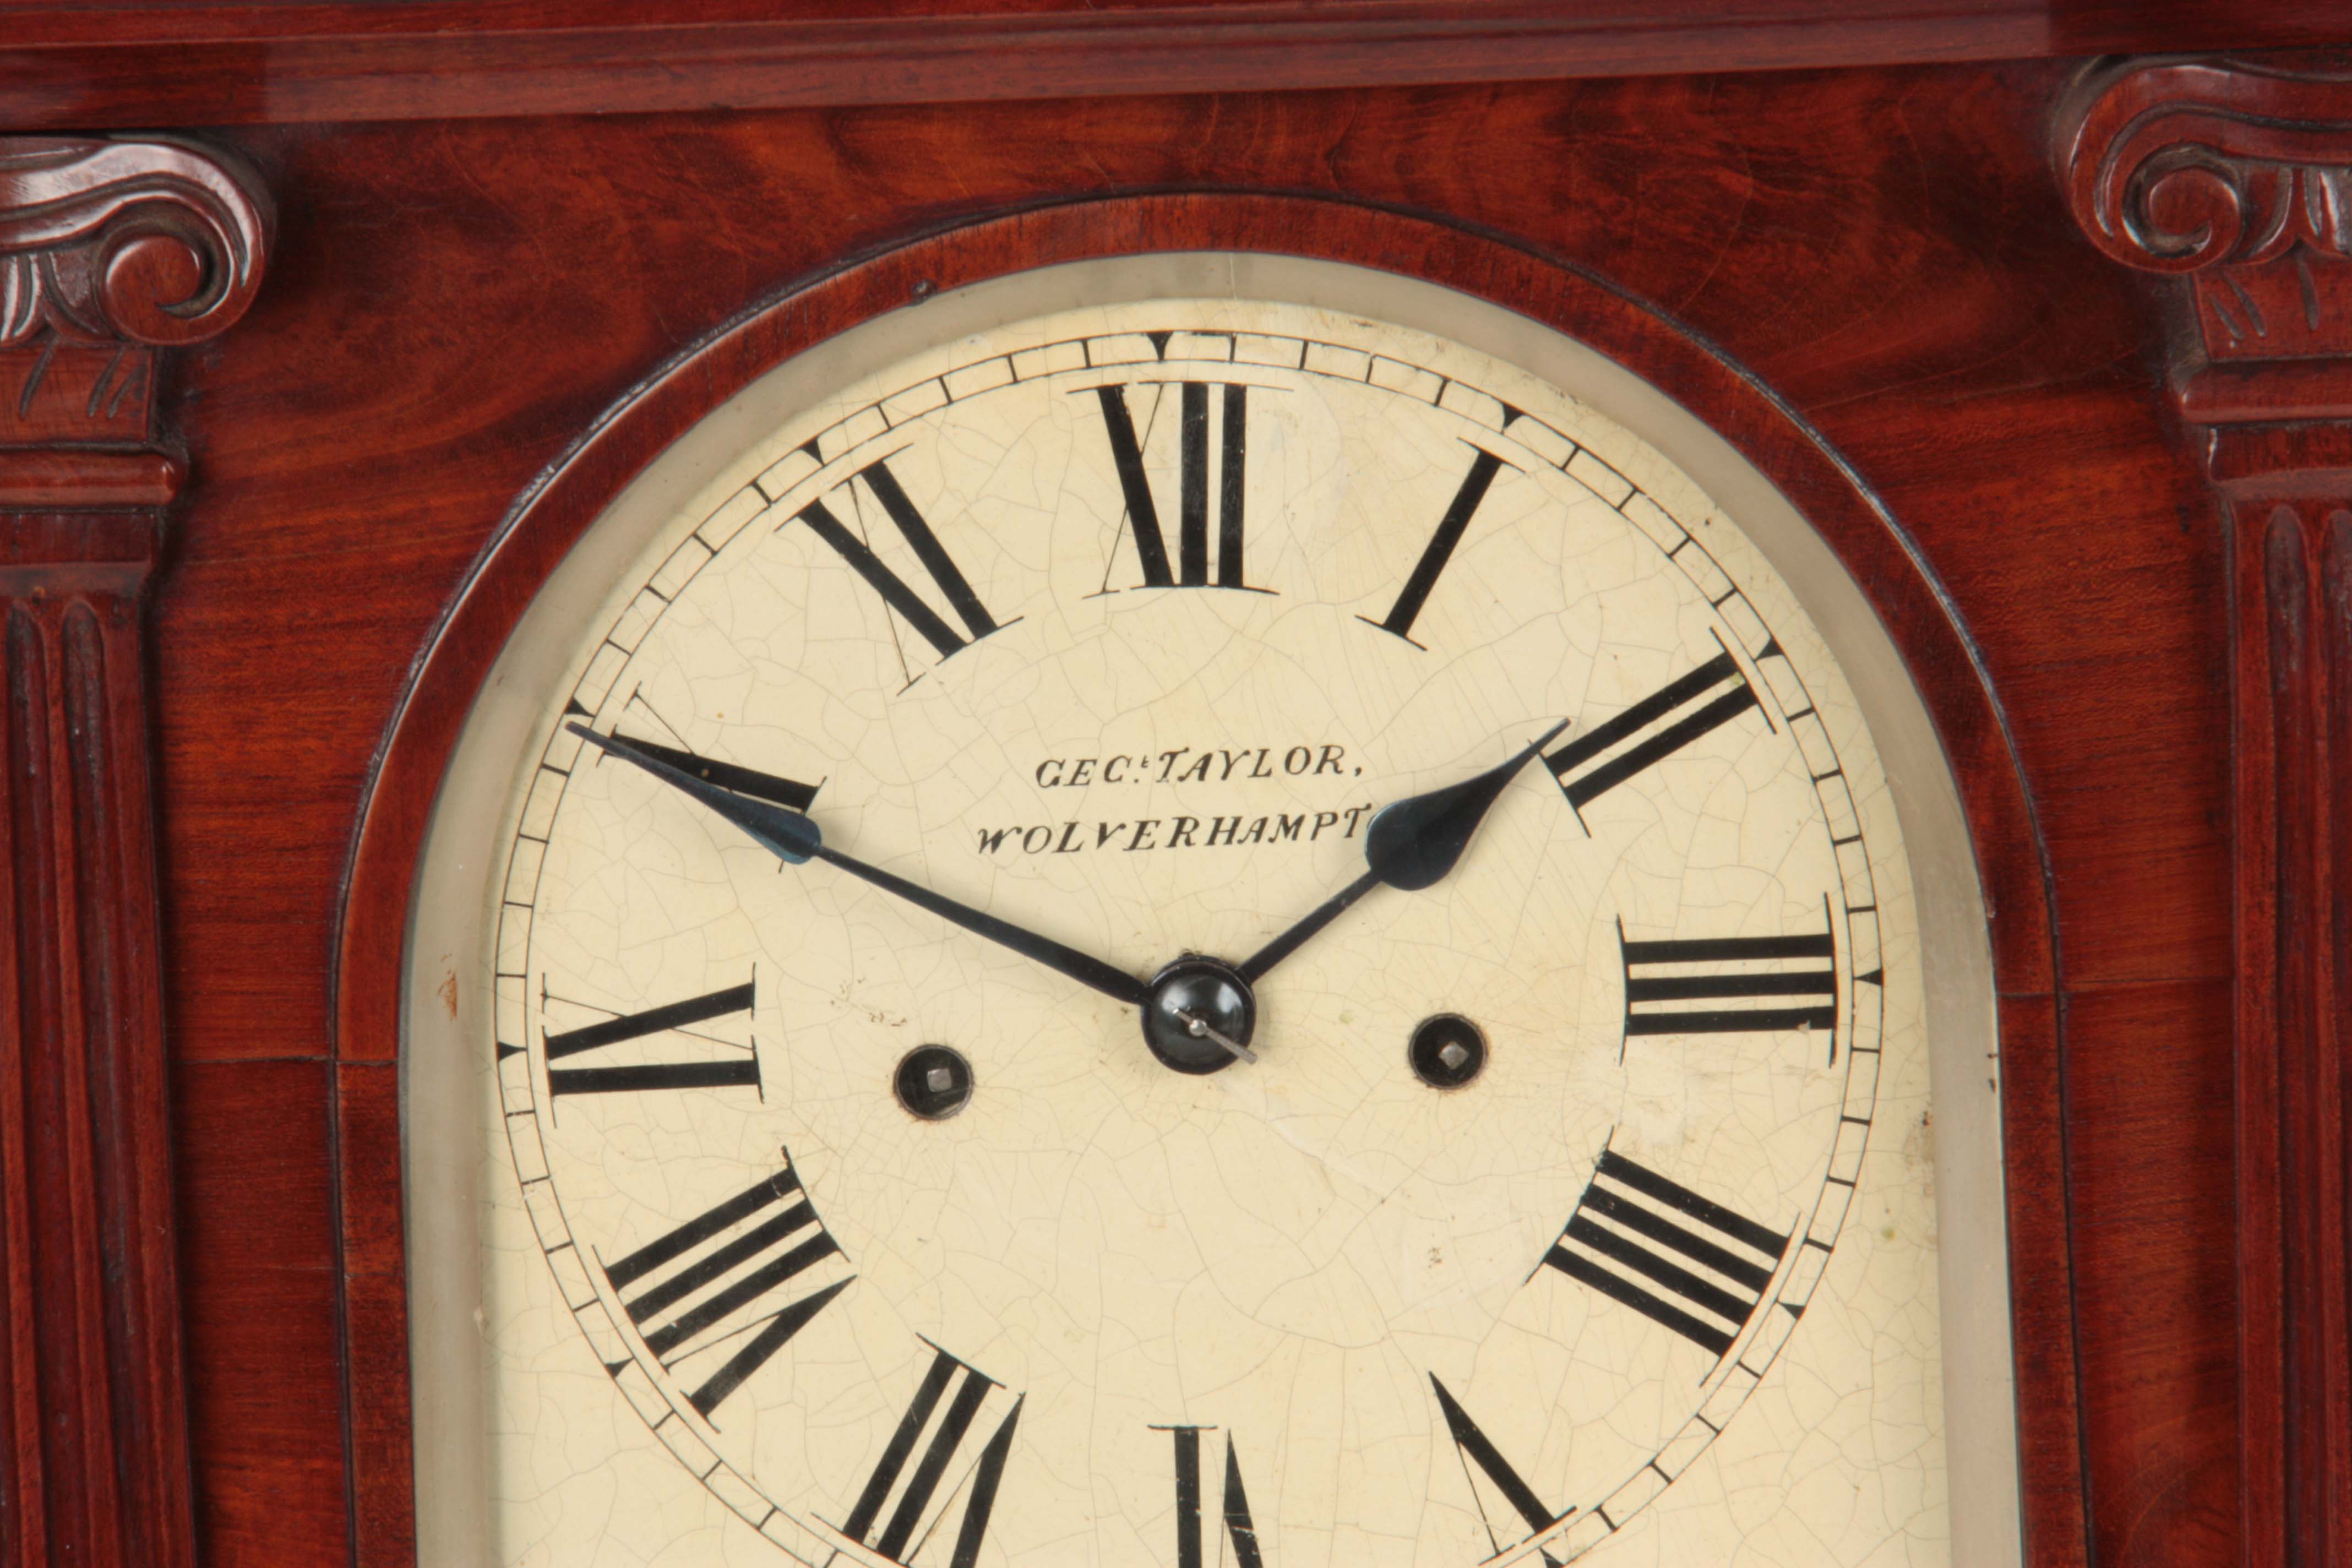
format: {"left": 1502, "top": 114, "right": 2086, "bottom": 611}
{"left": 1093, "top": 381, "right": 1249, "bottom": 587}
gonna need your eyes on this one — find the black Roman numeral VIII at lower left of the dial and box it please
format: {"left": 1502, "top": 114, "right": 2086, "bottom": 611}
{"left": 605, "top": 1164, "right": 849, "bottom": 1420}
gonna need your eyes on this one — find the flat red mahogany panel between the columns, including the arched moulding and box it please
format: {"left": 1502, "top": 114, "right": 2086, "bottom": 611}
{"left": 41, "top": 49, "right": 2237, "bottom": 1566}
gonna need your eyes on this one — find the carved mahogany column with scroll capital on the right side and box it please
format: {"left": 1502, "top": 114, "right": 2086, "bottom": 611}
{"left": 2060, "top": 59, "right": 2352, "bottom": 1568}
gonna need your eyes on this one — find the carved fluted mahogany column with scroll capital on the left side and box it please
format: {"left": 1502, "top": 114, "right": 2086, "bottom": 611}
{"left": 0, "top": 139, "right": 268, "bottom": 1568}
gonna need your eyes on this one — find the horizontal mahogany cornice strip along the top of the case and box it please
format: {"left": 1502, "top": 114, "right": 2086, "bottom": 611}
{"left": 0, "top": 0, "right": 2345, "bottom": 129}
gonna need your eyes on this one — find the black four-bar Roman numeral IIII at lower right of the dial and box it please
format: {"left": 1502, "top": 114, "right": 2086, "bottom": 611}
{"left": 1543, "top": 1150, "right": 1790, "bottom": 1359}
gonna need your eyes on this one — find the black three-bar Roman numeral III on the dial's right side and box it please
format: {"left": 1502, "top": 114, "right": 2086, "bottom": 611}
{"left": 1618, "top": 922, "right": 1837, "bottom": 1068}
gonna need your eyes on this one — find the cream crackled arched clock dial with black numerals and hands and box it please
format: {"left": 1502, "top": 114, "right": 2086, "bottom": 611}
{"left": 454, "top": 285, "right": 1947, "bottom": 1568}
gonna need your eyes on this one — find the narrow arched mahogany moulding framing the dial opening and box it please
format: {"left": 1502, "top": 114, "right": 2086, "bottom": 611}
{"left": 336, "top": 195, "right": 2086, "bottom": 1568}
